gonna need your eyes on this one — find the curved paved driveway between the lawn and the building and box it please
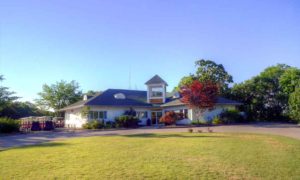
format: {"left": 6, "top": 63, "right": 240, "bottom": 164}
{"left": 0, "top": 123, "right": 300, "bottom": 149}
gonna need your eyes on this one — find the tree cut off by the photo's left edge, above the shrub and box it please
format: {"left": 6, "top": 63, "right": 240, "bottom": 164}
{"left": 0, "top": 75, "right": 18, "bottom": 116}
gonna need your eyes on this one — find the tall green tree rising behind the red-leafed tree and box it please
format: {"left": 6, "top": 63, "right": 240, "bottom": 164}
{"left": 177, "top": 59, "right": 233, "bottom": 95}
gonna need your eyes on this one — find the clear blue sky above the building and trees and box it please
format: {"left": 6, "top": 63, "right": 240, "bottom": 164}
{"left": 0, "top": 0, "right": 300, "bottom": 100}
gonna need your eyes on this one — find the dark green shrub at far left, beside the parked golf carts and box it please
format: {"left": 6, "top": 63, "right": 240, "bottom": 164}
{"left": 0, "top": 118, "right": 20, "bottom": 133}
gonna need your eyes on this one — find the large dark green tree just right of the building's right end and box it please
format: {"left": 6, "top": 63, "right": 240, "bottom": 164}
{"left": 231, "top": 64, "right": 290, "bottom": 121}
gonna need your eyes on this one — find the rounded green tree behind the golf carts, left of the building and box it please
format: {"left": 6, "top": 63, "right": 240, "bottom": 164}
{"left": 36, "top": 81, "right": 82, "bottom": 112}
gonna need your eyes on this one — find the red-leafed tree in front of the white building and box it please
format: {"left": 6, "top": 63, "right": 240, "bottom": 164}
{"left": 180, "top": 80, "right": 219, "bottom": 118}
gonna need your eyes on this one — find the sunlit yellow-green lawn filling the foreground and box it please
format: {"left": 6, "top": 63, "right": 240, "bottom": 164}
{"left": 0, "top": 133, "right": 300, "bottom": 179}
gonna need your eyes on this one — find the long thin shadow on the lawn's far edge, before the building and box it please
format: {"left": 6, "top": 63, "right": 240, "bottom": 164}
{"left": 123, "top": 133, "right": 227, "bottom": 138}
